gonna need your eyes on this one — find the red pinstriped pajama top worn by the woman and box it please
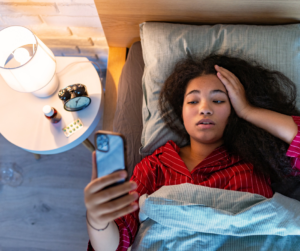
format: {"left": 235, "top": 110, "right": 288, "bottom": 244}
{"left": 87, "top": 116, "right": 300, "bottom": 251}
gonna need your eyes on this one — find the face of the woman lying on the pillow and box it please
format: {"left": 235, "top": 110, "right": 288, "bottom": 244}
{"left": 182, "top": 74, "right": 231, "bottom": 145}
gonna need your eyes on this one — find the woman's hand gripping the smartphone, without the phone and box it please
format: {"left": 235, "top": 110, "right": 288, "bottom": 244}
{"left": 84, "top": 151, "right": 138, "bottom": 229}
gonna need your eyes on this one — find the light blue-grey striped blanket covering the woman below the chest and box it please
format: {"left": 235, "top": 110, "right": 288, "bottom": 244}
{"left": 131, "top": 183, "right": 300, "bottom": 251}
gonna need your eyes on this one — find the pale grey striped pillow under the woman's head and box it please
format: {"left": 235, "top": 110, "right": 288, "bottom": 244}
{"left": 139, "top": 22, "right": 300, "bottom": 157}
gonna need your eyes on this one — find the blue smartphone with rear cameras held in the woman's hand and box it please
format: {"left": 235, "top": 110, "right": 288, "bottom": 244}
{"left": 95, "top": 130, "right": 129, "bottom": 199}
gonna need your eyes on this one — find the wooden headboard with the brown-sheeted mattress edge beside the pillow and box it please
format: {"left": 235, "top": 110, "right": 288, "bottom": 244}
{"left": 95, "top": 0, "right": 300, "bottom": 180}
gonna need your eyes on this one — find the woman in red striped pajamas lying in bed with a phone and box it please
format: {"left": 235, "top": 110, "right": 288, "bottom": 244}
{"left": 85, "top": 55, "right": 300, "bottom": 250}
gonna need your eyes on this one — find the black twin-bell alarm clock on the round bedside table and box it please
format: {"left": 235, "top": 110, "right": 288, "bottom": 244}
{"left": 58, "top": 84, "right": 92, "bottom": 112}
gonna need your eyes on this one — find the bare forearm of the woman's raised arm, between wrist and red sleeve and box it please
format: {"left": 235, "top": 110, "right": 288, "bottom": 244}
{"left": 243, "top": 107, "right": 298, "bottom": 144}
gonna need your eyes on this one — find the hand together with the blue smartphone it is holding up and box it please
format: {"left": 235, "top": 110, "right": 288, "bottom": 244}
{"left": 84, "top": 131, "right": 138, "bottom": 228}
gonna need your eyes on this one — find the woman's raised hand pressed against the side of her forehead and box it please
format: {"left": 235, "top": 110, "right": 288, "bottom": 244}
{"left": 215, "top": 65, "right": 253, "bottom": 118}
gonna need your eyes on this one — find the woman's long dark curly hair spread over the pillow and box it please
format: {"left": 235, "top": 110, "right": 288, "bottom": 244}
{"left": 158, "top": 53, "right": 300, "bottom": 184}
